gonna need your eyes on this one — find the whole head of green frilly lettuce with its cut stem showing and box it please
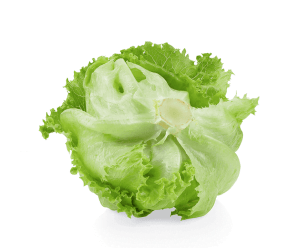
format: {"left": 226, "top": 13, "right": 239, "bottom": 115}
{"left": 40, "top": 42, "right": 258, "bottom": 220}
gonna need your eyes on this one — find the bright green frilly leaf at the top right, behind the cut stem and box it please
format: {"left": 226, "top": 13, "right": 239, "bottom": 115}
{"left": 111, "top": 42, "right": 233, "bottom": 108}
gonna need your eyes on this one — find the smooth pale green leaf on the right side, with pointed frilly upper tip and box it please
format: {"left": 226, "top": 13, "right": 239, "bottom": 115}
{"left": 172, "top": 96, "right": 258, "bottom": 219}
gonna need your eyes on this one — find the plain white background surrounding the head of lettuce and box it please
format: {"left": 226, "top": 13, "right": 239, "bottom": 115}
{"left": 0, "top": 0, "right": 300, "bottom": 248}
